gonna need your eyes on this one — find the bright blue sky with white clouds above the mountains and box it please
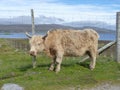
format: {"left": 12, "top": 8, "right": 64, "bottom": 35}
{"left": 0, "top": 0, "right": 120, "bottom": 24}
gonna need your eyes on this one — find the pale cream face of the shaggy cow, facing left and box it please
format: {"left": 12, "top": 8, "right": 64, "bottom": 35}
{"left": 26, "top": 34, "right": 44, "bottom": 56}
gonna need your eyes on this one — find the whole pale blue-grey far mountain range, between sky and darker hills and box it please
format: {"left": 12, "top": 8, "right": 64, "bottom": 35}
{"left": 0, "top": 15, "right": 115, "bottom": 30}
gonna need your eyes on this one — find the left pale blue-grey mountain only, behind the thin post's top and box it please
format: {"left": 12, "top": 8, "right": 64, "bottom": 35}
{"left": 0, "top": 15, "right": 64, "bottom": 25}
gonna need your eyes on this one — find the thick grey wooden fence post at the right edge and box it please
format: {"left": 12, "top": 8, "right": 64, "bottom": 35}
{"left": 116, "top": 12, "right": 120, "bottom": 63}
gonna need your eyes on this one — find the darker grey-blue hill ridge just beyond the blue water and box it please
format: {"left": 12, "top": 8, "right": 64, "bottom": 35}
{"left": 0, "top": 24, "right": 115, "bottom": 33}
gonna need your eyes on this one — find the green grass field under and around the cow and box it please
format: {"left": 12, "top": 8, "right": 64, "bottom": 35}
{"left": 0, "top": 39, "right": 120, "bottom": 90}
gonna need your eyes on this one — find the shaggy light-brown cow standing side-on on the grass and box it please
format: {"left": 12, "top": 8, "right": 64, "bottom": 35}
{"left": 26, "top": 29, "right": 99, "bottom": 72}
